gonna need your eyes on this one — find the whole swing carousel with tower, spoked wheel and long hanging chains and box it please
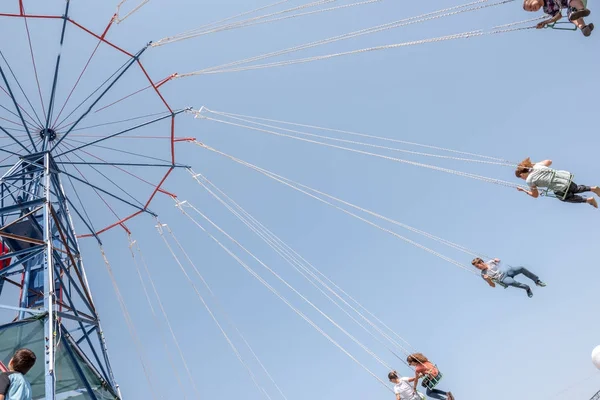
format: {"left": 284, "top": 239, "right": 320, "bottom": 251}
{"left": 0, "top": 0, "right": 599, "bottom": 400}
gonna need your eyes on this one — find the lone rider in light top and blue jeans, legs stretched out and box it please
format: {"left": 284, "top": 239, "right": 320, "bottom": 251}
{"left": 471, "top": 257, "right": 546, "bottom": 297}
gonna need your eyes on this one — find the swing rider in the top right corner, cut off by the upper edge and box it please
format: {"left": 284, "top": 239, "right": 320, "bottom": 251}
{"left": 523, "top": 0, "right": 594, "bottom": 37}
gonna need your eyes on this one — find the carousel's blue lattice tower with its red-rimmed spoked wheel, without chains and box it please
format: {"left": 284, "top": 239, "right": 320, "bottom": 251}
{"left": 0, "top": 0, "right": 186, "bottom": 400}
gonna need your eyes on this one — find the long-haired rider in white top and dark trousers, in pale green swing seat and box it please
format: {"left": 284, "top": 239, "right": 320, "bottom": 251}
{"left": 515, "top": 157, "right": 600, "bottom": 208}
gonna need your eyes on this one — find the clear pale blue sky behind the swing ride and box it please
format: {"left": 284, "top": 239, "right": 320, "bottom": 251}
{"left": 0, "top": 0, "right": 600, "bottom": 400}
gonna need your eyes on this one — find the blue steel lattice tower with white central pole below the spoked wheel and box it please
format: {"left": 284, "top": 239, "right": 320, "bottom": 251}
{"left": 0, "top": 152, "right": 120, "bottom": 400}
